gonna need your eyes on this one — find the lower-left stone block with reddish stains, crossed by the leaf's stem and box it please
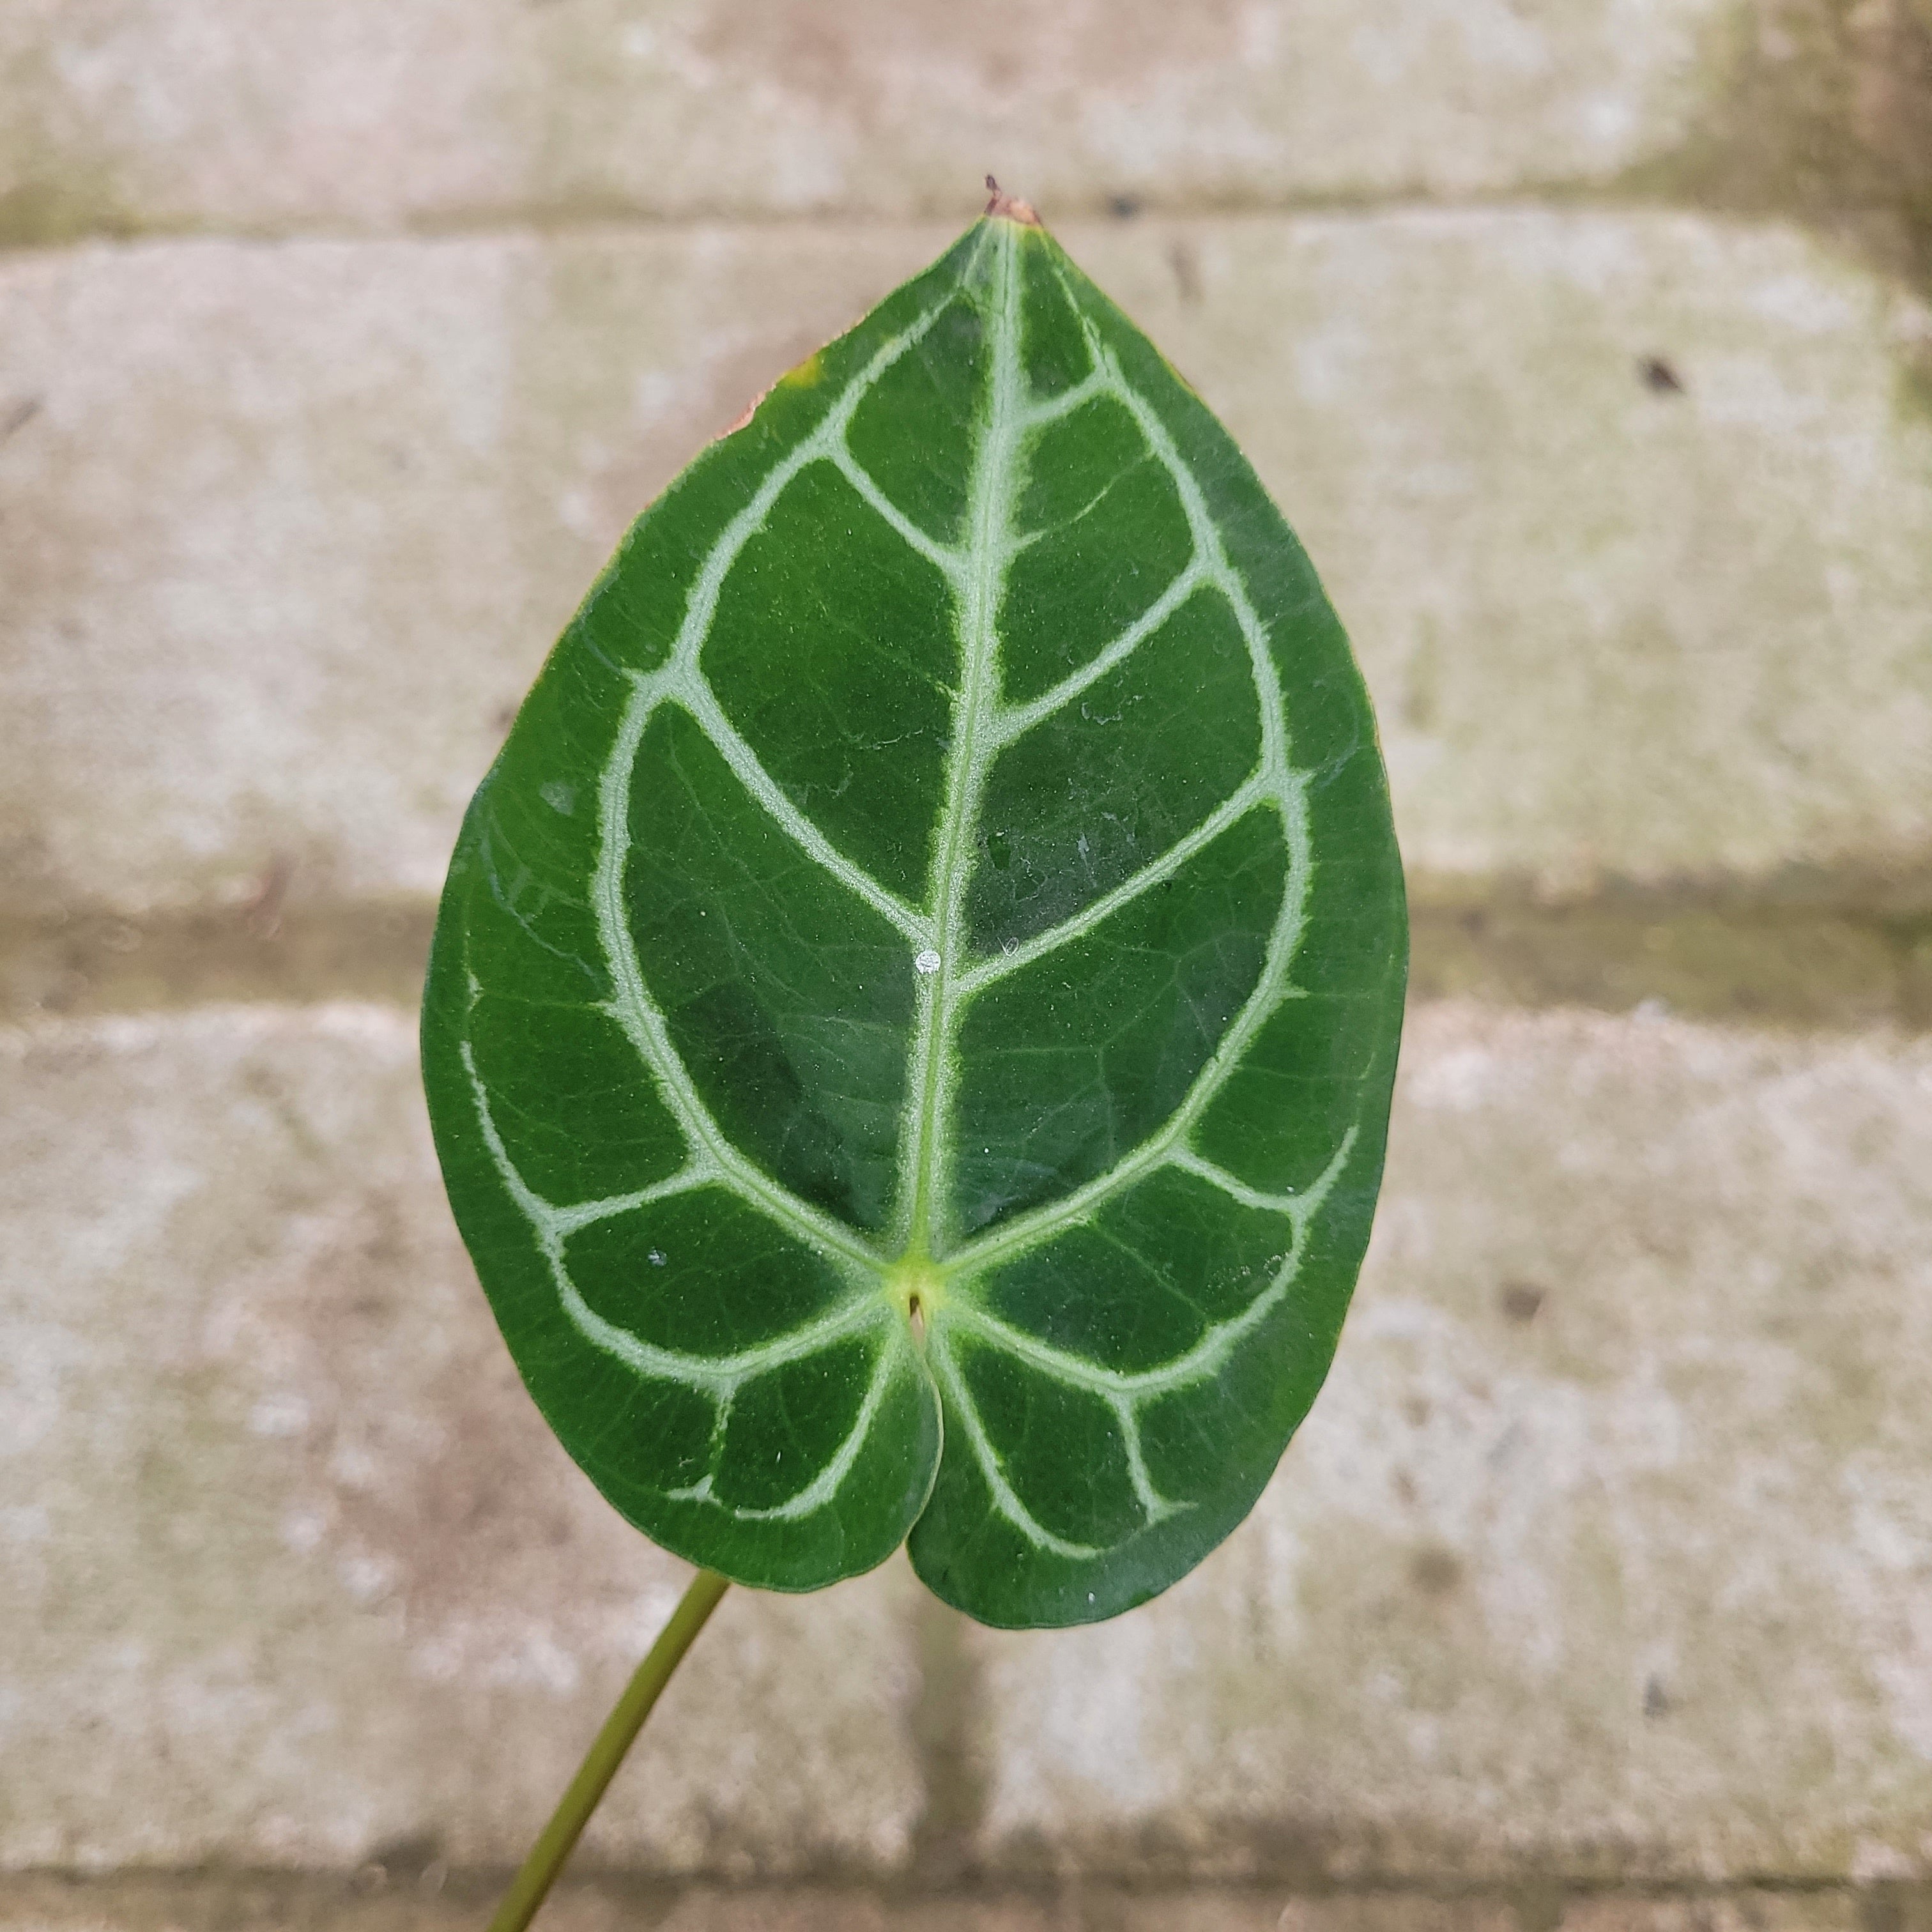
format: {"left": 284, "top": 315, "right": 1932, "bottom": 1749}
{"left": 0, "top": 1004, "right": 921, "bottom": 1891}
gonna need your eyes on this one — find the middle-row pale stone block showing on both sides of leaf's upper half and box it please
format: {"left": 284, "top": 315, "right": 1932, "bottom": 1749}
{"left": 0, "top": 213, "right": 1932, "bottom": 931}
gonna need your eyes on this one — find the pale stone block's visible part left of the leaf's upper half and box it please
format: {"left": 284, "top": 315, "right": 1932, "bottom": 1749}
{"left": 0, "top": 234, "right": 912, "bottom": 912}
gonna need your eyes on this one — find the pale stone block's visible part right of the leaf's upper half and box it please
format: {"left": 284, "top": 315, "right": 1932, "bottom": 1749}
{"left": 1080, "top": 211, "right": 1932, "bottom": 908}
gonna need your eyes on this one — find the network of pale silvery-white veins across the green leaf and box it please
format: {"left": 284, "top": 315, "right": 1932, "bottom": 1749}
{"left": 462, "top": 220, "right": 1354, "bottom": 1559}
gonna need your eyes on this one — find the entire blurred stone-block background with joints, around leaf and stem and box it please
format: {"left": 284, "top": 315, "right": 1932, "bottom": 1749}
{"left": 0, "top": 0, "right": 1932, "bottom": 1932}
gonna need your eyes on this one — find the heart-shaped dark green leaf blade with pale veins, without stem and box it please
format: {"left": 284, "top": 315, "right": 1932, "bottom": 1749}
{"left": 423, "top": 211, "right": 1406, "bottom": 1625}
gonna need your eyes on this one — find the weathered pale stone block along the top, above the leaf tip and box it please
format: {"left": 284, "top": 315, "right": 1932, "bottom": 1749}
{"left": 0, "top": 0, "right": 1737, "bottom": 240}
